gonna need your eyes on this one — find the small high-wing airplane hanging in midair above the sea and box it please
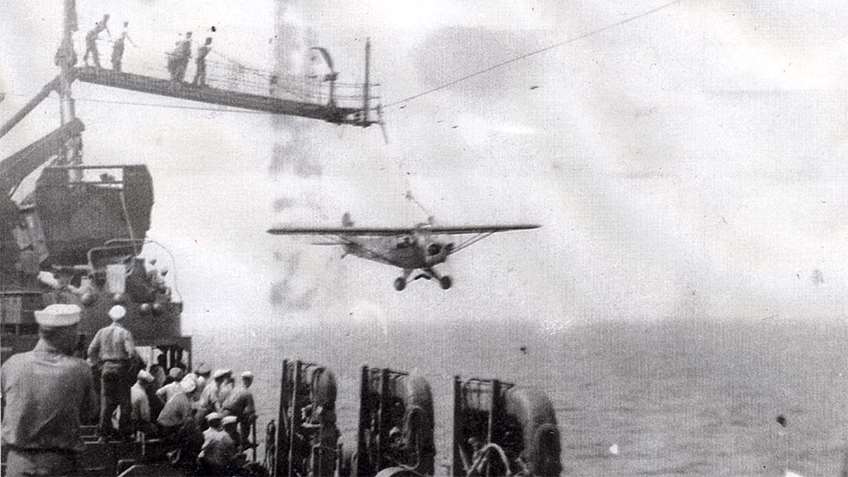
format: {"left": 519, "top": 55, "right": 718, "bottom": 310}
{"left": 268, "top": 213, "right": 539, "bottom": 291}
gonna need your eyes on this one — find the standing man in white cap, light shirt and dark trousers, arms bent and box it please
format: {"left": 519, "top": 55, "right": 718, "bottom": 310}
{"left": 88, "top": 305, "right": 140, "bottom": 439}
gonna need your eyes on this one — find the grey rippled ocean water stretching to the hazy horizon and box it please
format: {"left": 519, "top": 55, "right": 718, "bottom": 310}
{"left": 194, "top": 319, "right": 848, "bottom": 476}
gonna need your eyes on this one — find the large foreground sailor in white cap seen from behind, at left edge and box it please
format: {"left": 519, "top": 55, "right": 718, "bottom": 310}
{"left": 0, "top": 305, "right": 97, "bottom": 477}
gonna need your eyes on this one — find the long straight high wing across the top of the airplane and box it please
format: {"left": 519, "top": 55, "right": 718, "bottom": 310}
{"left": 268, "top": 224, "right": 540, "bottom": 237}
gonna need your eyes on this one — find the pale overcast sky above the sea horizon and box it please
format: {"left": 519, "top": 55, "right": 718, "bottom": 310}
{"left": 0, "top": 0, "right": 848, "bottom": 330}
